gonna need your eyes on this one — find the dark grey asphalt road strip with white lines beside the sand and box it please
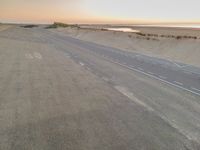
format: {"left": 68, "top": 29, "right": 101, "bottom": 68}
{"left": 48, "top": 30, "right": 200, "bottom": 96}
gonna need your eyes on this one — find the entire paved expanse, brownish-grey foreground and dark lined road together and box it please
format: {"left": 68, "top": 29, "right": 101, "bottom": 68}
{"left": 0, "top": 26, "right": 200, "bottom": 150}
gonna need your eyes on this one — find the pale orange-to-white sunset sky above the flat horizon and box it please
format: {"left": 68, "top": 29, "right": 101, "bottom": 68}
{"left": 0, "top": 0, "right": 200, "bottom": 24}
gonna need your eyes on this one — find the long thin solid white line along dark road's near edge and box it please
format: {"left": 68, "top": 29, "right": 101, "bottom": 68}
{"left": 108, "top": 60, "right": 200, "bottom": 96}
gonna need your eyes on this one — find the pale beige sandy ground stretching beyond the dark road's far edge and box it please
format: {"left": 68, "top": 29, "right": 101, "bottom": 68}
{"left": 52, "top": 27, "right": 200, "bottom": 67}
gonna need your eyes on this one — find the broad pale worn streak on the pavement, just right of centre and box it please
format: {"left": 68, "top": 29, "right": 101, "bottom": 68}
{"left": 115, "top": 86, "right": 154, "bottom": 111}
